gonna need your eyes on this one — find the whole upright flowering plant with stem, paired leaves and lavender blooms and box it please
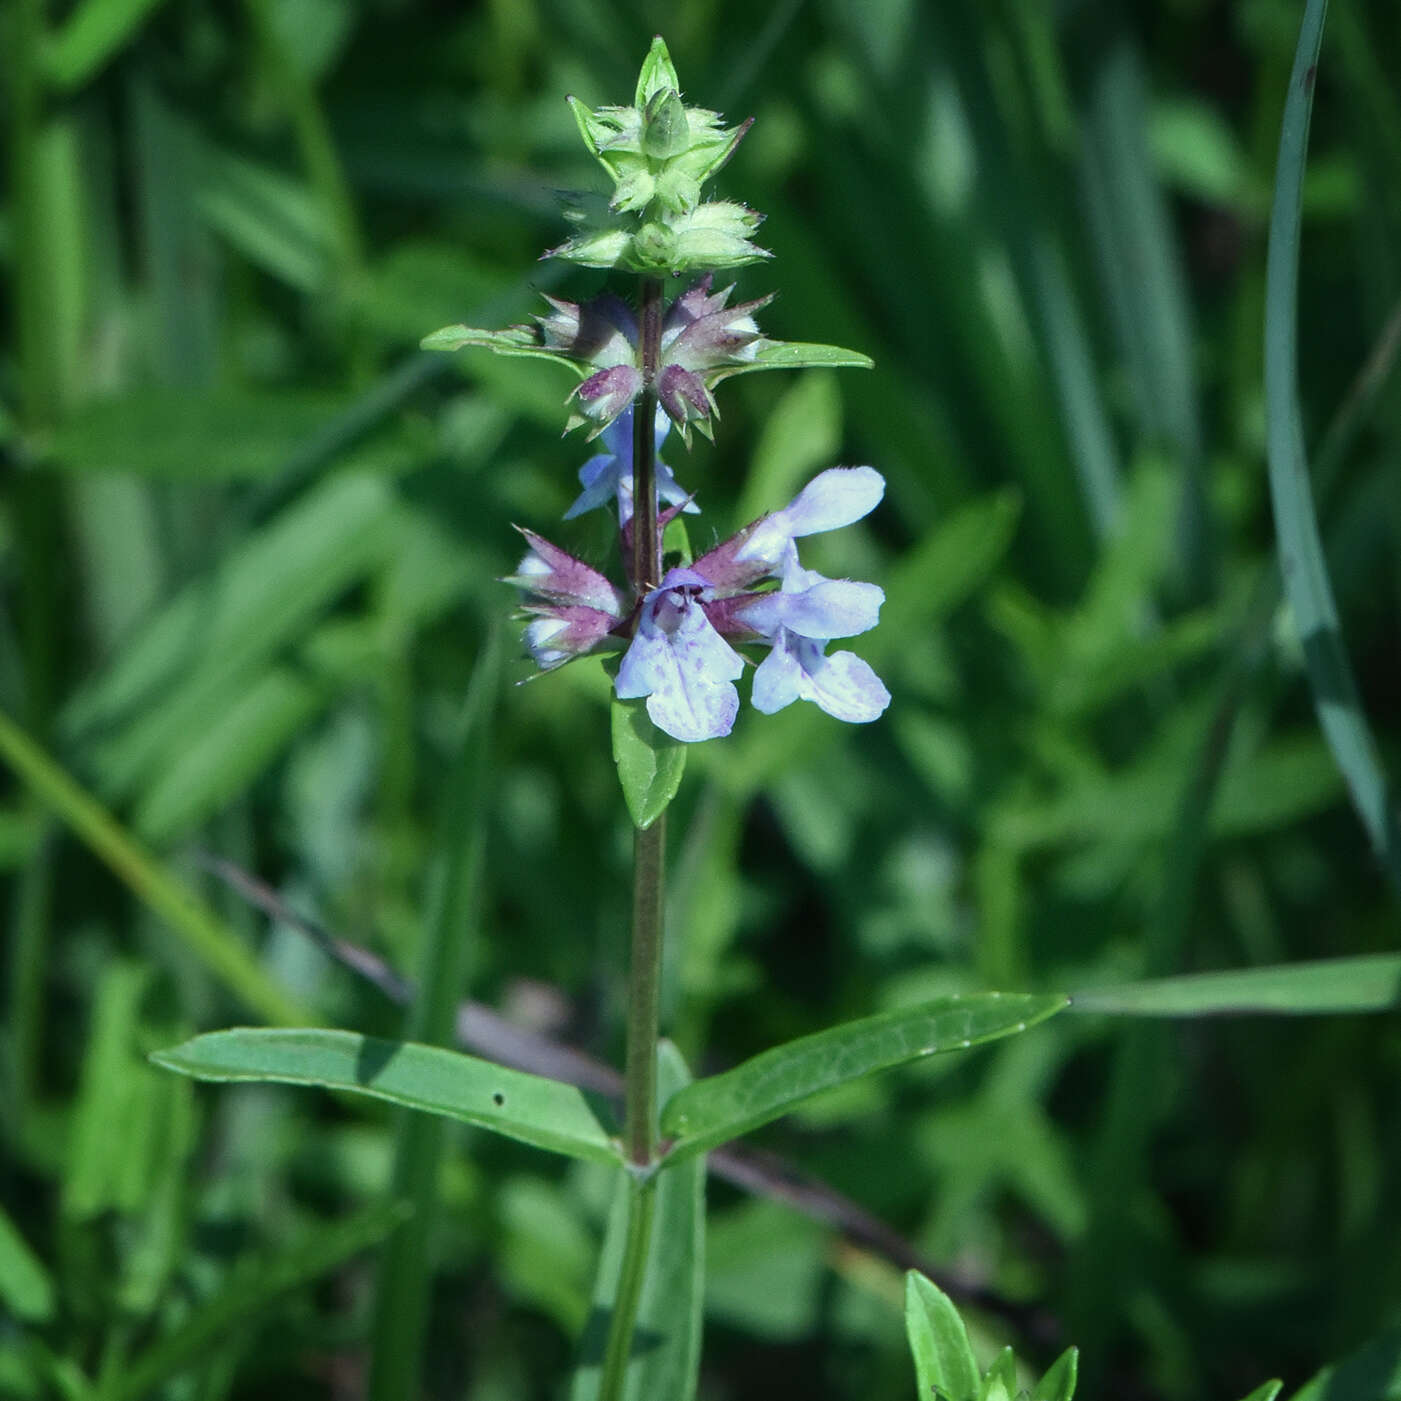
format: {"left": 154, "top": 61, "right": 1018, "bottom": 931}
{"left": 147, "top": 38, "right": 1065, "bottom": 1401}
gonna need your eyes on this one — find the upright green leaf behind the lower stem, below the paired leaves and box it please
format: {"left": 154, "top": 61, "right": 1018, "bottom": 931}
{"left": 569, "top": 1041, "right": 705, "bottom": 1401}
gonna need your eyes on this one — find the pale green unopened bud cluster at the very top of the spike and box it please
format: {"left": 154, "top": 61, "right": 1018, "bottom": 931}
{"left": 549, "top": 35, "right": 769, "bottom": 276}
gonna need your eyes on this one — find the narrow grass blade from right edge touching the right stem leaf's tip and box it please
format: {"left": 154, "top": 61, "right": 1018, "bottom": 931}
{"left": 1070, "top": 954, "right": 1401, "bottom": 1017}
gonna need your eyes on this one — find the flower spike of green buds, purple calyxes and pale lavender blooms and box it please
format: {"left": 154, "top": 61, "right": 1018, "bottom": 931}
{"left": 423, "top": 38, "right": 890, "bottom": 762}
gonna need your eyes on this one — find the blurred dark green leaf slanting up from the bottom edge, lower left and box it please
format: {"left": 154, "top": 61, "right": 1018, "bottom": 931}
{"left": 105, "top": 1202, "right": 403, "bottom": 1401}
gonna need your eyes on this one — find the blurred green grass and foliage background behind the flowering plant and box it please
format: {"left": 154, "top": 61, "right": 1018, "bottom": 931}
{"left": 0, "top": 0, "right": 1401, "bottom": 1401}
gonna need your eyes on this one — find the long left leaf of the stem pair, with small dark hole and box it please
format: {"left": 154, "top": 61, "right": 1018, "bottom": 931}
{"left": 151, "top": 1027, "right": 618, "bottom": 1163}
